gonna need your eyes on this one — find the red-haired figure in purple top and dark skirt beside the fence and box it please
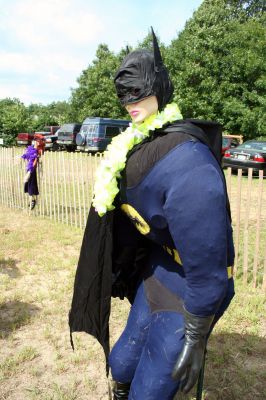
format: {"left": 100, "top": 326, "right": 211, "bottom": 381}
{"left": 21, "top": 134, "right": 45, "bottom": 210}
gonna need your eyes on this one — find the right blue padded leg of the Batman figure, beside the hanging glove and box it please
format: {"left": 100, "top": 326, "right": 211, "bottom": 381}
{"left": 128, "top": 311, "right": 184, "bottom": 400}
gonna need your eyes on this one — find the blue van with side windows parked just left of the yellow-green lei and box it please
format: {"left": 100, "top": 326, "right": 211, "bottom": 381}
{"left": 76, "top": 117, "right": 130, "bottom": 152}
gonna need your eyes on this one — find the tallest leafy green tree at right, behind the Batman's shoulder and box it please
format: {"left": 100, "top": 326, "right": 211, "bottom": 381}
{"left": 166, "top": 0, "right": 265, "bottom": 138}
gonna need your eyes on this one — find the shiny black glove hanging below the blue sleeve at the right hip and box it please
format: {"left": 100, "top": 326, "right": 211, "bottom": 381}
{"left": 172, "top": 310, "right": 214, "bottom": 393}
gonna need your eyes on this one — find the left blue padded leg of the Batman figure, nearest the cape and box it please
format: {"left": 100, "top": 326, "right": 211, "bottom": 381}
{"left": 109, "top": 283, "right": 151, "bottom": 383}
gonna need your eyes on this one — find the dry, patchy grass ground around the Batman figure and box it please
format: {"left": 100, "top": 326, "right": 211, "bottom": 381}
{"left": 0, "top": 207, "right": 266, "bottom": 400}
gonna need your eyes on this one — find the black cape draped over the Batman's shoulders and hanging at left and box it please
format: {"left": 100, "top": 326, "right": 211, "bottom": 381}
{"left": 69, "top": 120, "right": 230, "bottom": 374}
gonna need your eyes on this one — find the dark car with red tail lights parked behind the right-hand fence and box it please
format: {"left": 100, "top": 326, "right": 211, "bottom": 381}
{"left": 223, "top": 140, "right": 266, "bottom": 175}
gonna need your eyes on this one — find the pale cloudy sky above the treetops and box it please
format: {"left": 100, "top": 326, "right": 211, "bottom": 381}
{"left": 0, "top": 0, "right": 203, "bottom": 105}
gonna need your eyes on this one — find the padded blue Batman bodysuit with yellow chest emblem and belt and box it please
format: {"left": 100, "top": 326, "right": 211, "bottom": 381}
{"left": 109, "top": 137, "right": 234, "bottom": 400}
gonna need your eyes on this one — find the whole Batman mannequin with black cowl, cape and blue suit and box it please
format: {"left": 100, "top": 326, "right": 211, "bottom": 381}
{"left": 69, "top": 31, "right": 234, "bottom": 400}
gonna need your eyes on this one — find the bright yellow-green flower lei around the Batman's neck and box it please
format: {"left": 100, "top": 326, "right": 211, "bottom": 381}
{"left": 92, "top": 103, "right": 183, "bottom": 217}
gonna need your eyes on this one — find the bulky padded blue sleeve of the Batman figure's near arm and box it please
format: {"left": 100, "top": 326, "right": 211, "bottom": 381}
{"left": 164, "top": 164, "right": 227, "bottom": 317}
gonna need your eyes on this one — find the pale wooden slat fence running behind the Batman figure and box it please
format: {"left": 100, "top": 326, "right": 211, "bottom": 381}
{"left": 0, "top": 148, "right": 266, "bottom": 289}
